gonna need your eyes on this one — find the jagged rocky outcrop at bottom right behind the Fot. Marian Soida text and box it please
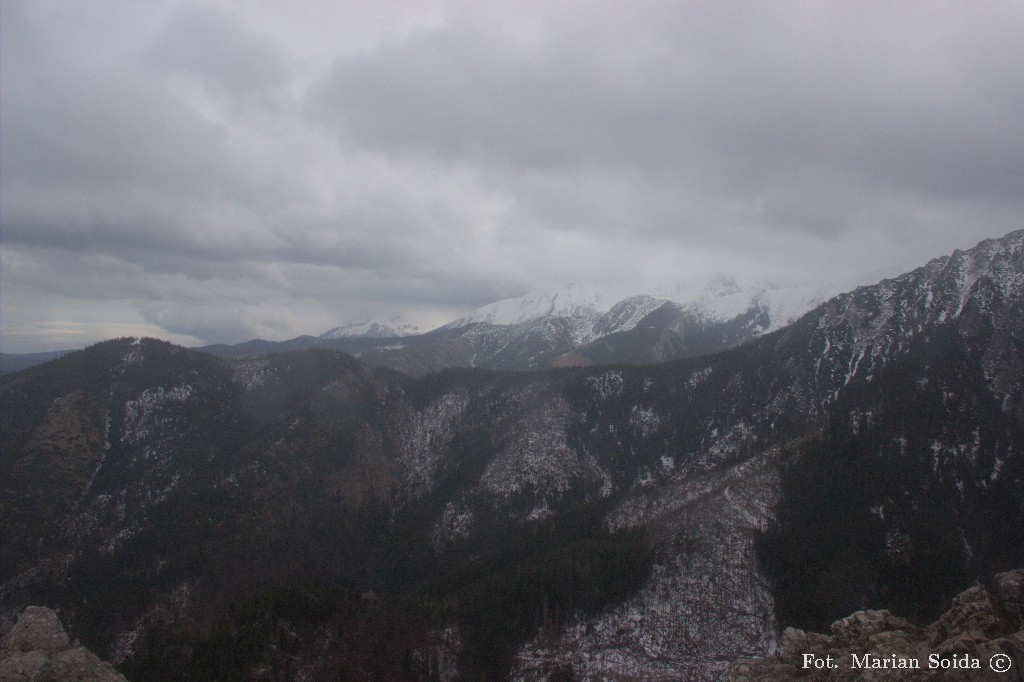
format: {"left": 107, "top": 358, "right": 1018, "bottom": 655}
{"left": 723, "top": 569, "right": 1024, "bottom": 682}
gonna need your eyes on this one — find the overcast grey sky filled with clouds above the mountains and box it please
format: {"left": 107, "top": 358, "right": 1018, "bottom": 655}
{"left": 0, "top": 0, "right": 1024, "bottom": 352}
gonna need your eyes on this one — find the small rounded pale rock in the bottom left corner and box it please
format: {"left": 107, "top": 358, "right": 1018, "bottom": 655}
{"left": 0, "top": 606, "right": 127, "bottom": 682}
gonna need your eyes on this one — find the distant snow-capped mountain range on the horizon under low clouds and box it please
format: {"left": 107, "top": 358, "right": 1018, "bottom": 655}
{"left": 193, "top": 275, "right": 853, "bottom": 376}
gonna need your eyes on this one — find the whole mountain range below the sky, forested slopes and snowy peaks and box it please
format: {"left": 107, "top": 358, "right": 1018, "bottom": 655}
{"left": 0, "top": 231, "right": 1024, "bottom": 680}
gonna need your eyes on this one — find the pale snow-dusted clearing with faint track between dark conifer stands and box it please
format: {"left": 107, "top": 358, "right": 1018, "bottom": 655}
{"left": 510, "top": 448, "right": 777, "bottom": 682}
